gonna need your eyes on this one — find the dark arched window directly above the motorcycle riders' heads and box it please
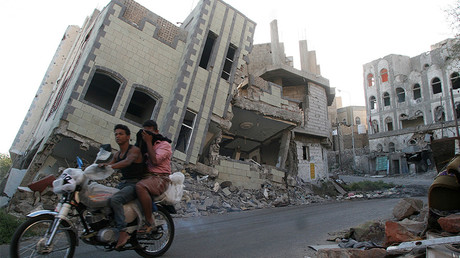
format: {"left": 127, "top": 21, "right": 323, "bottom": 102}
{"left": 125, "top": 90, "right": 156, "bottom": 124}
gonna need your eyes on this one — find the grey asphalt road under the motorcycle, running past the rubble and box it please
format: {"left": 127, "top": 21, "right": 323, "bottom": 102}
{"left": 0, "top": 199, "right": 414, "bottom": 258}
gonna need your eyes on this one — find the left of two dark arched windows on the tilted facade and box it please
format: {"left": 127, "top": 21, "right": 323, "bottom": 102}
{"left": 84, "top": 71, "right": 120, "bottom": 111}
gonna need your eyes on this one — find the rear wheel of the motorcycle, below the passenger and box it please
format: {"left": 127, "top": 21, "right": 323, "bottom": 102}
{"left": 135, "top": 206, "right": 174, "bottom": 257}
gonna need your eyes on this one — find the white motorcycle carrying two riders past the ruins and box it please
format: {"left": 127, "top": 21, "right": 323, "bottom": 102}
{"left": 10, "top": 145, "right": 183, "bottom": 258}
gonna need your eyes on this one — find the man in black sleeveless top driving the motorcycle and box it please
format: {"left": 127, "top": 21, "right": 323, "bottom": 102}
{"left": 98, "top": 124, "right": 144, "bottom": 249}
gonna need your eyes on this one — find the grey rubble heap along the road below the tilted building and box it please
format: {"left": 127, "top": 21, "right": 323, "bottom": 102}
{"left": 172, "top": 169, "right": 330, "bottom": 217}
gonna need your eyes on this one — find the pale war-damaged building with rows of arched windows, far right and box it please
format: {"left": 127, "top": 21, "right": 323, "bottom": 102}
{"left": 363, "top": 39, "right": 460, "bottom": 174}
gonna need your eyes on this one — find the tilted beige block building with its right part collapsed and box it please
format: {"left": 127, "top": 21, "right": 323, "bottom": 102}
{"left": 3, "top": 0, "right": 334, "bottom": 203}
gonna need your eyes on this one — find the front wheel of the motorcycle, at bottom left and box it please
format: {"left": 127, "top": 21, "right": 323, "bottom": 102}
{"left": 10, "top": 214, "right": 76, "bottom": 258}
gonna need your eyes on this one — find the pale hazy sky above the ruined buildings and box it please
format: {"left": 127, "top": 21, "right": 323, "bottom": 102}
{"left": 0, "top": 0, "right": 456, "bottom": 153}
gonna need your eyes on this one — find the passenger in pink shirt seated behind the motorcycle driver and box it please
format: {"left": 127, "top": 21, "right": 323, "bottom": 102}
{"left": 136, "top": 120, "right": 172, "bottom": 233}
